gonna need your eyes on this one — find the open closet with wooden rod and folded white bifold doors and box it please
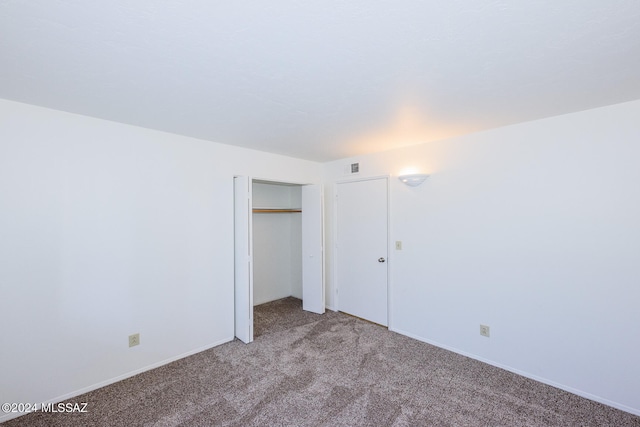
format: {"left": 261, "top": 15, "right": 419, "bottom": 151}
{"left": 233, "top": 176, "right": 325, "bottom": 343}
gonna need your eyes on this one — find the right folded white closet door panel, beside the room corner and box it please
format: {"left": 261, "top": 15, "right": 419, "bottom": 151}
{"left": 301, "top": 185, "right": 325, "bottom": 314}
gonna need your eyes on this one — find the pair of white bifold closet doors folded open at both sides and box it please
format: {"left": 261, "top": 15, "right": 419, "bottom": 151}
{"left": 234, "top": 176, "right": 325, "bottom": 343}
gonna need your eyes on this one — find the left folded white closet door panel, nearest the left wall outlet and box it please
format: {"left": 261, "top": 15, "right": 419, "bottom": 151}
{"left": 233, "top": 176, "right": 253, "bottom": 343}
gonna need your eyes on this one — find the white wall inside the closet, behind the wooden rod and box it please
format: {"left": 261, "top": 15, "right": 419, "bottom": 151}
{"left": 253, "top": 183, "right": 302, "bottom": 305}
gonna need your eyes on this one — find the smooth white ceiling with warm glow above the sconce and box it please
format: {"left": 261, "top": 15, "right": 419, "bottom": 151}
{"left": 0, "top": 0, "right": 640, "bottom": 161}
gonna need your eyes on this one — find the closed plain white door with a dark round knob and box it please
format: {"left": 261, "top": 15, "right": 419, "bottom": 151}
{"left": 336, "top": 178, "right": 388, "bottom": 326}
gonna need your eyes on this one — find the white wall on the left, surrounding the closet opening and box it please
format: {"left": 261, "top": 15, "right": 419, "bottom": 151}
{"left": 0, "top": 100, "right": 321, "bottom": 421}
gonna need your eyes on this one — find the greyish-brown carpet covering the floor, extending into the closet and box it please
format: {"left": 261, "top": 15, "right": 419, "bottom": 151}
{"left": 6, "top": 299, "right": 640, "bottom": 427}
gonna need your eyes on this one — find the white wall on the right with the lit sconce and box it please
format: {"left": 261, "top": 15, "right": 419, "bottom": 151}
{"left": 325, "top": 101, "right": 640, "bottom": 414}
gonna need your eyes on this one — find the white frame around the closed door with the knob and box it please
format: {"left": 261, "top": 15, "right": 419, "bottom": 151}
{"left": 331, "top": 175, "right": 393, "bottom": 330}
